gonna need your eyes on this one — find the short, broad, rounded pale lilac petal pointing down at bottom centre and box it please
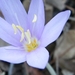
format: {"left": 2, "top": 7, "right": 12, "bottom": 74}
{"left": 27, "top": 47, "right": 49, "bottom": 69}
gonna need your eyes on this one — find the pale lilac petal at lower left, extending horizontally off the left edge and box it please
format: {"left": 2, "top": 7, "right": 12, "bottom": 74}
{"left": 0, "top": 46, "right": 26, "bottom": 64}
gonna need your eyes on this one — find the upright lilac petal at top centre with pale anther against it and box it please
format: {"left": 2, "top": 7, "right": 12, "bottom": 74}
{"left": 28, "top": 0, "right": 45, "bottom": 38}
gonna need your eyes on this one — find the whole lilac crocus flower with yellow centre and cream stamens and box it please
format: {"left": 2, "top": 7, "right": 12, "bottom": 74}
{"left": 0, "top": 0, "right": 70, "bottom": 69}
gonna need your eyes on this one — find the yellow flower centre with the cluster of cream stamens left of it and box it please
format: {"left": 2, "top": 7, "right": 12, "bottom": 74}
{"left": 12, "top": 24, "right": 39, "bottom": 52}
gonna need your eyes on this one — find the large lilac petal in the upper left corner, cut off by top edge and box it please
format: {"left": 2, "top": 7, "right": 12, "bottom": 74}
{"left": 0, "top": 0, "right": 27, "bottom": 30}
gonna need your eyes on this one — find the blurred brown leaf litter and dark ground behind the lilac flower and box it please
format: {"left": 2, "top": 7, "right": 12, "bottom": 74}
{"left": 0, "top": 0, "right": 75, "bottom": 75}
